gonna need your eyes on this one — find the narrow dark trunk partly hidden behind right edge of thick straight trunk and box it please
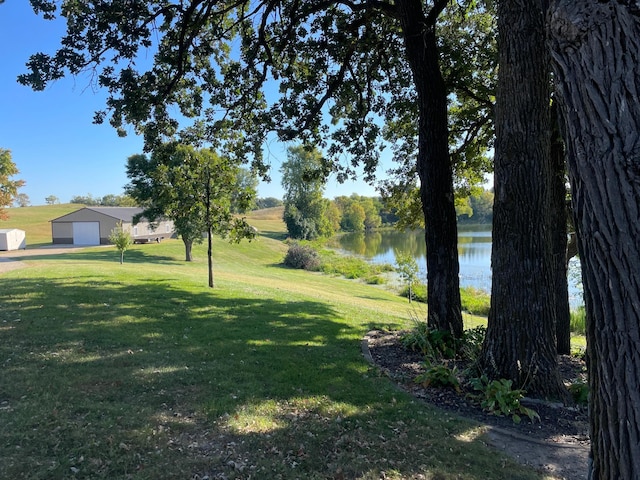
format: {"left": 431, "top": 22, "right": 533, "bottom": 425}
{"left": 549, "top": 102, "right": 571, "bottom": 355}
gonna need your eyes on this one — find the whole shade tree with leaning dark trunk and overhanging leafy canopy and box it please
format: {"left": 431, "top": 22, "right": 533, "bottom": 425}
{"left": 20, "top": 0, "right": 500, "bottom": 336}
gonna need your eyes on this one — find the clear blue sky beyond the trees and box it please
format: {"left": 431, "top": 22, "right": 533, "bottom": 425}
{"left": 0, "top": 0, "right": 384, "bottom": 205}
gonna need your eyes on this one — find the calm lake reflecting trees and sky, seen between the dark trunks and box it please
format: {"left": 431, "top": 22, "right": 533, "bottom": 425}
{"left": 333, "top": 225, "right": 583, "bottom": 308}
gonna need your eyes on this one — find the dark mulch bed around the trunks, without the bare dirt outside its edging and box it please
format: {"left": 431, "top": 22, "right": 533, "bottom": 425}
{"left": 363, "top": 331, "right": 589, "bottom": 445}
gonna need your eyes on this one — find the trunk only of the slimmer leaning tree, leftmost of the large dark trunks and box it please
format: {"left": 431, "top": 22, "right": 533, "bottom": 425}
{"left": 396, "top": 0, "right": 463, "bottom": 338}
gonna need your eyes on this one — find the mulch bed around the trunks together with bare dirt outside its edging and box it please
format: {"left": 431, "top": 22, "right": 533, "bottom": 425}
{"left": 362, "top": 330, "right": 589, "bottom": 480}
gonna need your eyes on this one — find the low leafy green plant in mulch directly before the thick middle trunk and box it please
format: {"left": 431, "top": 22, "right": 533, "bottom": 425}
{"left": 470, "top": 375, "right": 540, "bottom": 423}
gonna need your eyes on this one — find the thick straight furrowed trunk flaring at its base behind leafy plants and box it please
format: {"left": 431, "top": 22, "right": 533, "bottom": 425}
{"left": 481, "top": 0, "right": 566, "bottom": 398}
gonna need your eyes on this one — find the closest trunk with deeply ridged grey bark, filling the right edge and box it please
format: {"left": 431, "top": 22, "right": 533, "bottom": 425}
{"left": 549, "top": 0, "right": 640, "bottom": 480}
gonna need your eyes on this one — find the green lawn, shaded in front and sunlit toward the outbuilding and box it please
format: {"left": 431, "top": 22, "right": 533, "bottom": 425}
{"left": 0, "top": 208, "right": 544, "bottom": 480}
